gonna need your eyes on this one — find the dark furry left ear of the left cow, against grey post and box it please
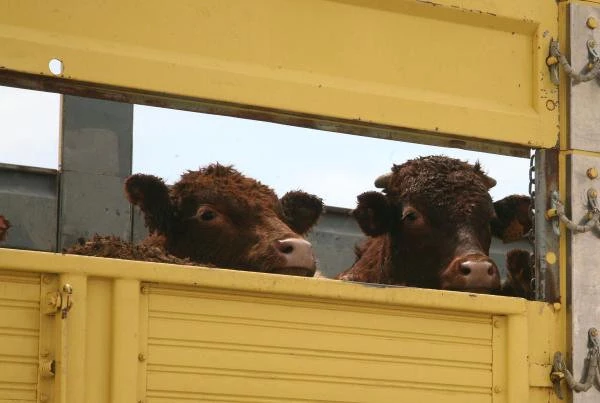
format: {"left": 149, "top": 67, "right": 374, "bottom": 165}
{"left": 125, "top": 174, "right": 175, "bottom": 235}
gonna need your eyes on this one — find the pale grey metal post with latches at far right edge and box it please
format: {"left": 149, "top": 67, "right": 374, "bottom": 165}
{"left": 561, "top": 3, "right": 600, "bottom": 403}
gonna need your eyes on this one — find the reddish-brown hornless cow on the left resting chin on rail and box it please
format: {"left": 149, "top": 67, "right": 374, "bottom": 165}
{"left": 68, "top": 163, "right": 323, "bottom": 276}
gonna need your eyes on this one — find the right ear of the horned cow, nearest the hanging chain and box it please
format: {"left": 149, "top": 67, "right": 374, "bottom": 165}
{"left": 491, "top": 195, "right": 532, "bottom": 243}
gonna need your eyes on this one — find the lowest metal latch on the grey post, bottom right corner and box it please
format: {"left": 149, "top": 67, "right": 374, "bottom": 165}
{"left": 550, "top": 328, "right": 600, "bottom": 400}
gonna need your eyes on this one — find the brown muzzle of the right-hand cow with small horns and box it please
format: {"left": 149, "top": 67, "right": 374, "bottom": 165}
{"left": 440, "top": 254, "right": 500, "bottom": 293}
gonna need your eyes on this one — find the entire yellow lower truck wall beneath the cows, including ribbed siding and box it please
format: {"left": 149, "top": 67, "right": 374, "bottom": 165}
{"left": 0, "top": 249, "right": 564, "bottom": 403}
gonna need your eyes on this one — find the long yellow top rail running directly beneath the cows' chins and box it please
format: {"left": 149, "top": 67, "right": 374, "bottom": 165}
{"left": 0, "top": 249, "right": 527, "bottom": 315}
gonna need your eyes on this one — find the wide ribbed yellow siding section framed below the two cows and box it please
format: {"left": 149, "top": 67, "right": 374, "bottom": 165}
{"left": 142, "top": 288, "right": 496, "bottom": 403}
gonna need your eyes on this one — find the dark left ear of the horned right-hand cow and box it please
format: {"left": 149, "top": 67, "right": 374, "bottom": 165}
{"left": 352, "top": 192, "right": 393, "bottom": 236}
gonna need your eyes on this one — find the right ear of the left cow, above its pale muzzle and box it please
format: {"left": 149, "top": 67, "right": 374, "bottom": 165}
{"left": 280, "top": 190, "right": 323, "bottom": 235}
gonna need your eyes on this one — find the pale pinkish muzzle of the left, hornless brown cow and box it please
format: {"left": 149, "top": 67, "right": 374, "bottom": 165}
{"left": 273, "top": 238, "right": 316, "bottom": 277}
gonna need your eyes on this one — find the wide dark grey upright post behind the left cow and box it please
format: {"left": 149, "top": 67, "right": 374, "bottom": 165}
{"left": 58, "top": 96, "right": 133, "bottom": 249}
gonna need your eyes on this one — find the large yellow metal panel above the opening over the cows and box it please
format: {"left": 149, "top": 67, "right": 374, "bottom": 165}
{"left": 0, "top": 0, "right": 558, "bottom": 147}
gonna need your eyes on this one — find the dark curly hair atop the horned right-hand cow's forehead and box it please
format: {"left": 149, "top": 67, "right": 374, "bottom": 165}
{"left": 386, "top": 156, "right": 493, "bottom": 221}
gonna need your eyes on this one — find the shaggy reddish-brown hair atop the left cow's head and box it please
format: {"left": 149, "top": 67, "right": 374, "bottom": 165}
{"left": 171, "top": 164, "right": 279, "bottom": 210}
